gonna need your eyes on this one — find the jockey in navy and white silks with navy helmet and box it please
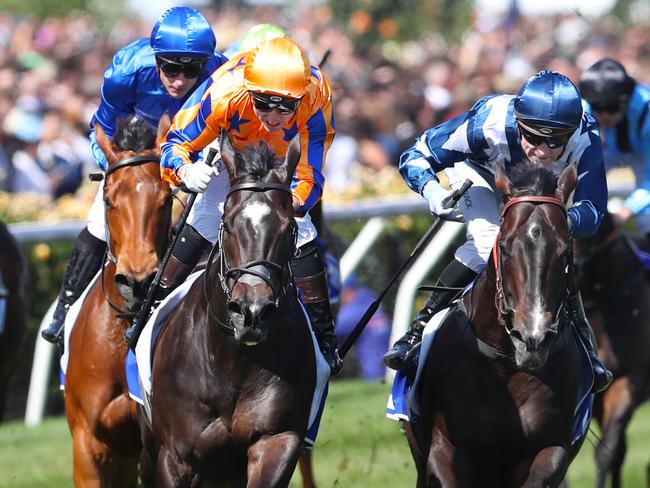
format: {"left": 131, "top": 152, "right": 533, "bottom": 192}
{"left": 384, "top": 71, "right": 611, "bottom": 391}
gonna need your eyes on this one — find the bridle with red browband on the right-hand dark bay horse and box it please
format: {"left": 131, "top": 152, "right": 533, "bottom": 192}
{"left": 492, "top": 196, "right": 573, "bottom": 334}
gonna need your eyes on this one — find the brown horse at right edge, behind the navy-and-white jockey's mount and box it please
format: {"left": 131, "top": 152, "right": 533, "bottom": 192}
{"left": 576, "top": 214, "right": 650, "bottom": 488}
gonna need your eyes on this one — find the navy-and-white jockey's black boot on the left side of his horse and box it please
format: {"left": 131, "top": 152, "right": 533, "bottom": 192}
{"left": 384, "top": 259, "right": 476, "bottom": 370}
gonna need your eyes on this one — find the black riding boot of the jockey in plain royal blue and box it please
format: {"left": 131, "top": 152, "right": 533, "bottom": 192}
{"left": 41, "top": 228, "right": 106, "bottom": 345}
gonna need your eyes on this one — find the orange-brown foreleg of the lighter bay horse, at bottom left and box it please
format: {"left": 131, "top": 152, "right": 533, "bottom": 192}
{"left": 72, "top": 428, "right": 106, "bottom": 488}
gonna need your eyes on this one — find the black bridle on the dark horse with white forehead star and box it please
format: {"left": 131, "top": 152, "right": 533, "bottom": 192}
{"left": 203, "top": 181, "right": 298, "bottom": 332}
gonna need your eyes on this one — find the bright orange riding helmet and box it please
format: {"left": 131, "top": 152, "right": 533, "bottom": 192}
{"left": 244, "top": 37, "right": 311, "bottom": 98}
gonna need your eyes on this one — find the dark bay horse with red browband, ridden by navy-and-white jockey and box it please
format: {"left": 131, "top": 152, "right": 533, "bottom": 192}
{"left": 406, "top": 164, "right": 584, "bottom": 488}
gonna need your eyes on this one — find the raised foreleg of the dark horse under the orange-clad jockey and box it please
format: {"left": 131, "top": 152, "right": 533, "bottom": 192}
{"left": 246, "top": 432, "right": 302, "bottom": 488}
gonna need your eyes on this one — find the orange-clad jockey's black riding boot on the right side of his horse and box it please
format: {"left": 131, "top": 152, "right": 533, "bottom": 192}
{"left": 291, "top": 242, "right": 343, "bottom": 375}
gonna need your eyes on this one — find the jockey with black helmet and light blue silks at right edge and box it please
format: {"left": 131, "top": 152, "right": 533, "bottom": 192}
{"left": 580, "top": 59, "right": 650, "bottom": 240}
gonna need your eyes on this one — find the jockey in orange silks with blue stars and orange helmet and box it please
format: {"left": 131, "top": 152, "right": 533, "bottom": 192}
{"left": 127, "top": 37, "right": 341, "bottom": 374}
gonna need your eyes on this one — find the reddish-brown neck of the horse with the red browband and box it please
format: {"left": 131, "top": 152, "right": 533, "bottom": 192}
{"left": 463, "top": 263, "right": 512, "bottom": 352}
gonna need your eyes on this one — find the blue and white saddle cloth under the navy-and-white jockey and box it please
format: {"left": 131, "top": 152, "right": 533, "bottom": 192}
{"left": 386, "top": 308, "right": 594, "bottom": 443}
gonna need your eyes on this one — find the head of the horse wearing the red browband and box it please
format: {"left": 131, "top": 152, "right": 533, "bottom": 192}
{"left": 492, "top": 164, "right": 577, "bottom": 371}
